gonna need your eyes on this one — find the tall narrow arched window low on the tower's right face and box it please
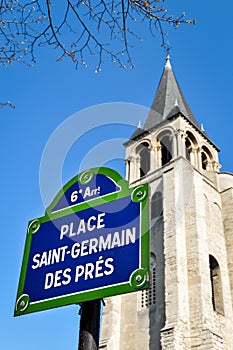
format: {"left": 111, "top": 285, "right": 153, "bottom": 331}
{"left": 209, "top": 255, "right": 224, "bottom": 315}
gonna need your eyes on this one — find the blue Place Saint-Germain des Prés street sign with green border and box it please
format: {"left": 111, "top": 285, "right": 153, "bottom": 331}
{"left": 15, "top": 168, "right": 149, "bottom": 316}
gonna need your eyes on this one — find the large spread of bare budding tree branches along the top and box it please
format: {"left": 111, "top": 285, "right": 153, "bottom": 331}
{"left": 0, "top": 0, "right": 195, "bottom": 72}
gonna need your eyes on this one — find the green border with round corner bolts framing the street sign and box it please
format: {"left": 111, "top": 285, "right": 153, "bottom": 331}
{"left": 14, "top": 167, "right": 150, "bottom": 316}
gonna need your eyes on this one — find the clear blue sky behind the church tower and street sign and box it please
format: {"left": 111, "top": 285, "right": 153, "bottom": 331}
{"left": 0, "top": 0, "right": 233, "bottom": 350}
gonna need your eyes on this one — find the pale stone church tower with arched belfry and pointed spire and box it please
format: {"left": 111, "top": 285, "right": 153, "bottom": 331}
{"left": 100, "top": 57, "right": 233, "bottom": 350}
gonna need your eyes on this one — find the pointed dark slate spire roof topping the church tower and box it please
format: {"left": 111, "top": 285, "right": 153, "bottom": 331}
{"left": 144, "top": 56, "right": 199, "bottom": 130}
